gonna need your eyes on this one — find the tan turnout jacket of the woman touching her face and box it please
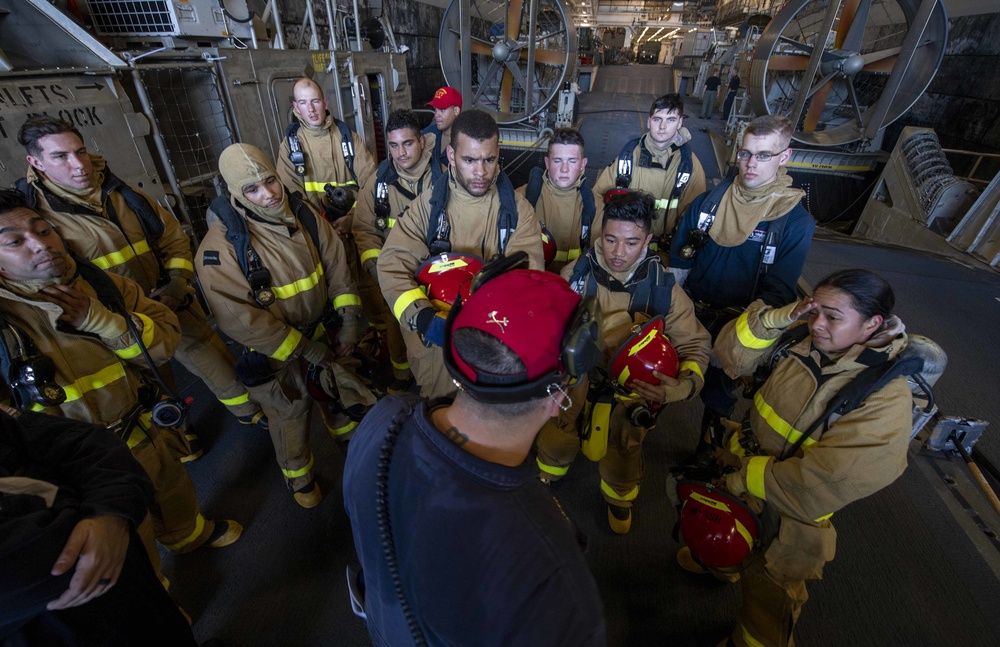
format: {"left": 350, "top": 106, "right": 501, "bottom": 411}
{"left": 715, "top": 300, "right": 913, "bottom": 579}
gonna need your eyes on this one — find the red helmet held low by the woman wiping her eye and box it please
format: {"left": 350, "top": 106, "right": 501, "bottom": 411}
{"left": 677, "top": 479, "right": 760, "bottom": 572}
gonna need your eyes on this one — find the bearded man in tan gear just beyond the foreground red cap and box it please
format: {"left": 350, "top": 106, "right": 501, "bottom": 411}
{"left": 378, "top": 110, "right": 543, "bottom": 398}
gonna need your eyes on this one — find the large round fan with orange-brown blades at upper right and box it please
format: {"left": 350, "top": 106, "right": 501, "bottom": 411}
{"left": 748, "top": 0, "right": 948, "bottom": 146}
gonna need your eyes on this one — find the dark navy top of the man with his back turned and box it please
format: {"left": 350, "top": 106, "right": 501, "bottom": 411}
{"left": 344, "top": 396, "right": 607, "bottom": 647}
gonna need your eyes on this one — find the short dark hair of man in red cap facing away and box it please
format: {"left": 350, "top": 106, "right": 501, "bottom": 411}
{"left": 451, "top": 328, "right": 538, "bottom": 419}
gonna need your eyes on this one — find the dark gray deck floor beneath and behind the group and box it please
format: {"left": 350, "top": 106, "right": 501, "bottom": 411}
{"left": 165, "top": 66, "right": 1000, "bottom": 647}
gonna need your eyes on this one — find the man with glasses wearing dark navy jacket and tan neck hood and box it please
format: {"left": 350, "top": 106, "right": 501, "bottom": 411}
{"left": 670, "top": 115, "right": 816, "bottom": 460}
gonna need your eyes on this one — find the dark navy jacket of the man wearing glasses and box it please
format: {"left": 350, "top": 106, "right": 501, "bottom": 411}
{"left": 669, "top": 186, "right": 816, "bottom": 308}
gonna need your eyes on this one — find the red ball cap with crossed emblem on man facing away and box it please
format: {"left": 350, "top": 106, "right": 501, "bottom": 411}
{"left": 447, "top": 270, "right": 581, "bottom": 384}
